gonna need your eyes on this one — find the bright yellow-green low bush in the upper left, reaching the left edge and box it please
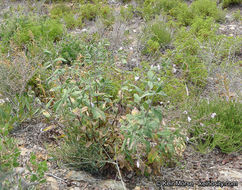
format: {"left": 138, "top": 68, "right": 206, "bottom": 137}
{"left": 0, "top": 16, "right": 64, "bottom": 52}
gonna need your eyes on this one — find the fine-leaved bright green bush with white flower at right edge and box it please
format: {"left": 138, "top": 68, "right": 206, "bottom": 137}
{"left": 189, "top": 98, "right": 242, "bottom": 153}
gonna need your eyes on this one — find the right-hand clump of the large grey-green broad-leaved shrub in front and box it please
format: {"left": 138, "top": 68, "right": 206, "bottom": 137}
{"left": 121, "top": 67, "right": 184, "bottom": 174}
